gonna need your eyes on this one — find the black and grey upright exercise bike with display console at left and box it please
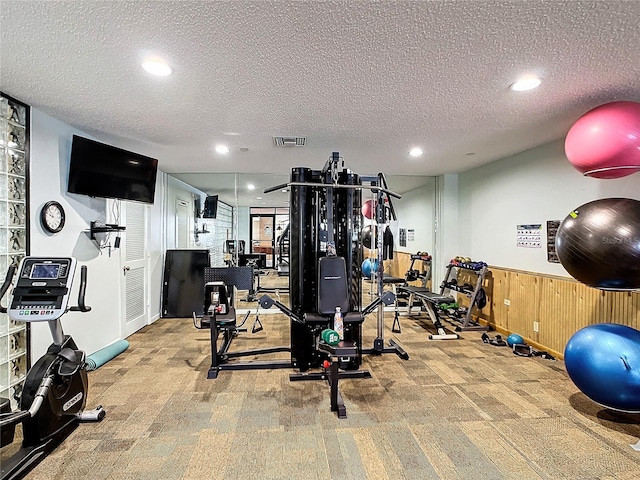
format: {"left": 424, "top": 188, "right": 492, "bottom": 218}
{"left": 0, "top": 257, "right": 105, "bottom": 480}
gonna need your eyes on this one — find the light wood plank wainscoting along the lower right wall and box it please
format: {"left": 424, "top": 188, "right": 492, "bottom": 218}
{"left": 385, "top": 252, "right": 640, "bottom": 359}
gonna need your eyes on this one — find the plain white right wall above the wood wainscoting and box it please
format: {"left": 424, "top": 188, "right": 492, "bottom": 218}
{"left": 459, "top": 141, "right": 640, "bottom": 276}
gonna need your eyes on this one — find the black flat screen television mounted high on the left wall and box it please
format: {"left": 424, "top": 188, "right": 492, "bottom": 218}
{"left": 67, "top": 135, "right": 158, "bottom": 203}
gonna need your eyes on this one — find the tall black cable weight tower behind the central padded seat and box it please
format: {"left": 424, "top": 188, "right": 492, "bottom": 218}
{"left": 264, "top": 152, "right": 409, "bottom": 372}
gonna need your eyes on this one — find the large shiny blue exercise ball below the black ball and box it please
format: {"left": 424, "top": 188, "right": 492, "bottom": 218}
{"left": 564, "top": 323, "right": 640, "bottom": 413}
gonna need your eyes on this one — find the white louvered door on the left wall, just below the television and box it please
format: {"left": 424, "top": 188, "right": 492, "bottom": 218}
{"left": 120, "top": 202, "right": 149, "bottom": 337}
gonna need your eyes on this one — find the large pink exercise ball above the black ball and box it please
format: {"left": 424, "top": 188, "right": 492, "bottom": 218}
{"left": 564, "top": 101, "right": 640, "bottom": 178}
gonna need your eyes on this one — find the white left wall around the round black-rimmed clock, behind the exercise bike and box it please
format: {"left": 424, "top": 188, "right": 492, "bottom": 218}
{"left": 29, "top": 109, "right": 121, "bottom": 358}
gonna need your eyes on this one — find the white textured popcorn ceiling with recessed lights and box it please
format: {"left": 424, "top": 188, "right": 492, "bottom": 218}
{"left": 0, "top": 0, "right": 640, "bottom": 203}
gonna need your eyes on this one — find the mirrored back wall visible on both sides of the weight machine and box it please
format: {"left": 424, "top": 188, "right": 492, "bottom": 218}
{"left": 172, "top": 173, "right": 434, "bottom": 311}
